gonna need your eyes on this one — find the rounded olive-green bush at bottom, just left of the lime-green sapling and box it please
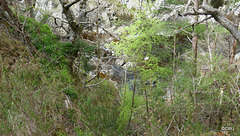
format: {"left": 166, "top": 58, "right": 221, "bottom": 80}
{"left": 79, "top": 80, "right": 119, "bottom": 135}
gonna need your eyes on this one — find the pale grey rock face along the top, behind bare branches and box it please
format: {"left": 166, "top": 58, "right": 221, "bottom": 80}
{"left": 35, "top": 0, "right": 172, "bottom": 42}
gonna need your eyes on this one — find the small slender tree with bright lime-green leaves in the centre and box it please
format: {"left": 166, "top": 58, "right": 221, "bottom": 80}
{"left": 107, "top": 4, "right": 174, "bottom": 134}
